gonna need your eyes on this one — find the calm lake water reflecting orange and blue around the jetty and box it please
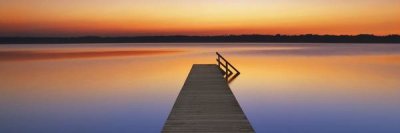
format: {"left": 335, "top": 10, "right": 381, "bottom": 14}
{"left": 0, "top": 43, "right": 400, "bottom": 133}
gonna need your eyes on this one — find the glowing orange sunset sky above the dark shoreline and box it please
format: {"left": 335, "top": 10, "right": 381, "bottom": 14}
{"left": 0, "top": 0, "right": 400, "bottom": 36}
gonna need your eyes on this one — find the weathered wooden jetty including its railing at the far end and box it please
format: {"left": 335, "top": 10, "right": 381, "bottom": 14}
{"left": 162, "top": 53, "right": 254, "bottom": 133}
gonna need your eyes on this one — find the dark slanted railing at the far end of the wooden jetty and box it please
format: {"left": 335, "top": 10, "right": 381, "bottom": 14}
{"left": 216, "top": 52, "right": 240, "bottom": 83}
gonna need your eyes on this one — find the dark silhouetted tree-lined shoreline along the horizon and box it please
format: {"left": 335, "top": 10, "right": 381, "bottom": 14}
{"left": 0, "top": 34, "right": 400, "bottom": 44}
